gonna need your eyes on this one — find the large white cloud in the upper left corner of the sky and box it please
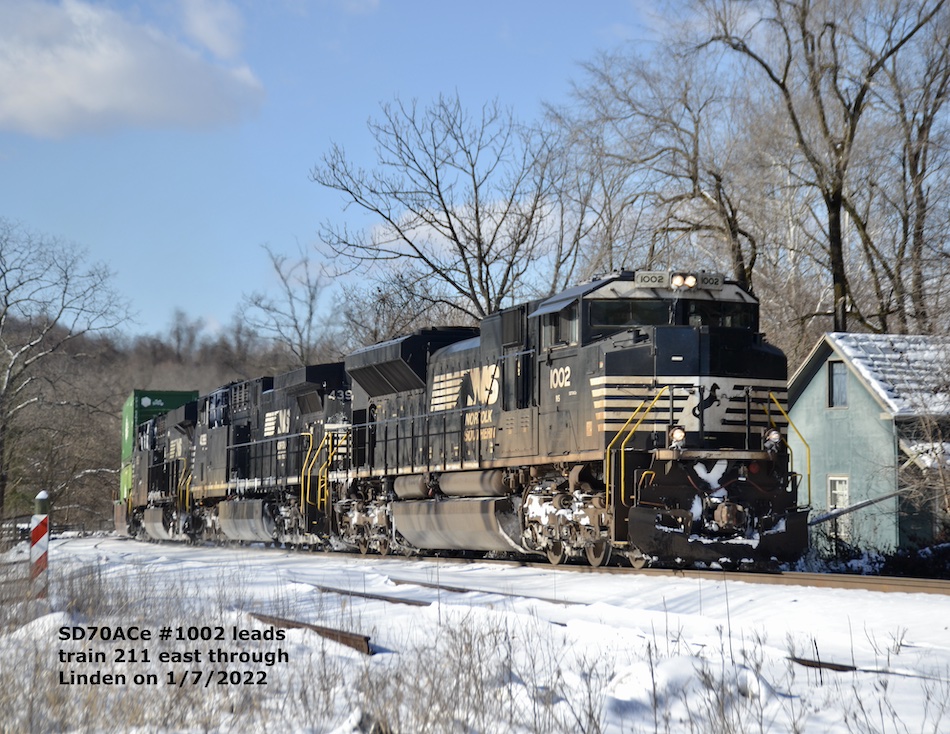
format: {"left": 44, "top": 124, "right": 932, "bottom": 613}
{"left": 0, "top": 0, "right": 263, "bottom": 137}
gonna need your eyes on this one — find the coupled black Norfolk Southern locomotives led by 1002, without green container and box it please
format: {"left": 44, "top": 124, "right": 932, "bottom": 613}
{"left": 117, "top": 271, "right": 807, "bottom": 566}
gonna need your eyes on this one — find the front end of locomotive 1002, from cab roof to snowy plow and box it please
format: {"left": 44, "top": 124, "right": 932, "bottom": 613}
{"left": 529, "top": 271, "right": 807, "bottom": 565}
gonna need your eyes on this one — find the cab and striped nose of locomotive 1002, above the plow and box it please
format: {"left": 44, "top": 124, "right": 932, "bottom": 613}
{"left": 530, "top": 272, "right": 787, "bottom": 449}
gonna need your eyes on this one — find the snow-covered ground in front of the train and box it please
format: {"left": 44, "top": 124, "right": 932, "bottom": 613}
{"left": 0, "top": 537, "right": 950, "bottom": 734}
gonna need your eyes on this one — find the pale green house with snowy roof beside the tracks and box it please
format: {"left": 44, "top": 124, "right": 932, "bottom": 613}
{"left": 788, "top": 333, "right": 950, "bottom": 552}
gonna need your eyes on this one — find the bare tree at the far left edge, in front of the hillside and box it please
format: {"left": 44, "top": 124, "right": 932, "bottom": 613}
{"left": 0, "top": 219, "right": 128, "bottom": 513}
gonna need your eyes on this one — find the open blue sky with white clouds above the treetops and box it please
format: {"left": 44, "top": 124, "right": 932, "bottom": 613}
{"left": 0, "top": 0, "right": 653, "bottom": 334}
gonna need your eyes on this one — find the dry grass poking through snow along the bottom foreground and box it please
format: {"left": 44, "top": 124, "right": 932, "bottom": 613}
{"left": 0, "top": 552, "right": 950, "bottom": 734}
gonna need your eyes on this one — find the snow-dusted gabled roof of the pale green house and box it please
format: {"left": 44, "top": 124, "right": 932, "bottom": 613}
{"left": 788, "top": 333, "right": 950, "bottom": 418}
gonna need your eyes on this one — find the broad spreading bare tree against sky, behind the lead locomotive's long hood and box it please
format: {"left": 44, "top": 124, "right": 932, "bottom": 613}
{"left": 311, "top": 96, "right": 569, "bottom": 319}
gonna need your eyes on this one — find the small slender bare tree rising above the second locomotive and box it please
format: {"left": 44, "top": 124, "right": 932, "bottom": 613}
{"left": 242, "top": 245, "right": 333, "bottom": 367}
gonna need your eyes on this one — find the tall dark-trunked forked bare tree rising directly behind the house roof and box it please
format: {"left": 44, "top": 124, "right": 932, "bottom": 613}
{"left": 702, "top": 0, "right": 945, "bottom": 331}
